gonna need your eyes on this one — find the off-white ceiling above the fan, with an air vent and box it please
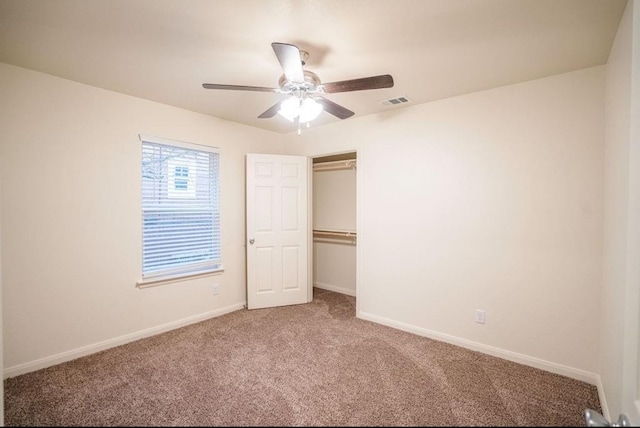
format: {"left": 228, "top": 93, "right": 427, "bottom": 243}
{"left": 0, "top": 0, "right": 626, "bottom": 133}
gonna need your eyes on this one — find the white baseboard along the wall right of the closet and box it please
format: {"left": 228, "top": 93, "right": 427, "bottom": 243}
{"left": 357, "top": 311, "right": 606, "bottom": 386}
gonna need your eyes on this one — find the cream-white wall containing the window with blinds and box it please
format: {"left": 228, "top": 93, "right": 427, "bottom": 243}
{"left": 0, "top": 64, "right": 282, "bottom": 375}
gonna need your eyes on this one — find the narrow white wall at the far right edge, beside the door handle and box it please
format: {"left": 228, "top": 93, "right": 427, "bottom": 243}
{"left": 599, "top": 2, "right": 640, "bottom": 425}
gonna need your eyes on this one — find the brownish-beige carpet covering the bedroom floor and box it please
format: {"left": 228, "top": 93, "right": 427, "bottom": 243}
{"left": 5, "top": 289, "right": 601, "bottom": 426}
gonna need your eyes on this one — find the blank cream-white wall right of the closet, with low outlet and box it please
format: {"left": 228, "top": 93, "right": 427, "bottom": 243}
{"left": 285, "top": 66, "right": 605, "bottom": 382}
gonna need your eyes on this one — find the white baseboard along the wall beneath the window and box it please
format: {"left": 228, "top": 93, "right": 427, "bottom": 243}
{"left": 3, "top": 302, "right": 246, "bottom": 379}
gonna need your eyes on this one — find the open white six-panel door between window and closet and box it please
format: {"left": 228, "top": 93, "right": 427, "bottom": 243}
{"left": 246, "top": 154, "right": 312, "bottom": 309}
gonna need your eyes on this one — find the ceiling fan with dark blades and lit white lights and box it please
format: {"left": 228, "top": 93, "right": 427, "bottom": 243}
{"left": 202, "top": 42, "right": 393, "bottom": 132}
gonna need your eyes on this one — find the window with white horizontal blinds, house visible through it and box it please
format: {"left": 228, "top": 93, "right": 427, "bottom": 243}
{"left": 140, "top": 135, "right": 222, "bottom": 283}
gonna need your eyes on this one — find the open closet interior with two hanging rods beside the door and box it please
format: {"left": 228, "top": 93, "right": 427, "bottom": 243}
{"left": 312, "top": 152, "right": 358, "bottom": 297}
